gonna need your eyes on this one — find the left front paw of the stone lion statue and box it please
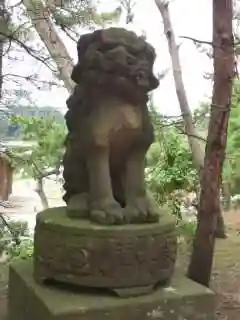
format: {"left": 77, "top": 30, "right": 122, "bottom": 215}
{"left": 90, "top": 199, "right": 124, "bottom": 225}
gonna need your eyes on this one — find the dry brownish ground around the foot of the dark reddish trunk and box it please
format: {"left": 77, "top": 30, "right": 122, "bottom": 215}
{"left": 177, "top": 210, "right": 240, "bottom": 320}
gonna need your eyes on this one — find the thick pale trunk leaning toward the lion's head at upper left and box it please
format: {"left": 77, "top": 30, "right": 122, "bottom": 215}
{"left": 23, "top": 0, "right": 74, "bottom": 92}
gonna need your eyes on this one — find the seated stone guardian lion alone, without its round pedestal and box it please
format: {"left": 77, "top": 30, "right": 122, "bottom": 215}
{"left": 64, "top": 28, "right": 160, "bottom": 225}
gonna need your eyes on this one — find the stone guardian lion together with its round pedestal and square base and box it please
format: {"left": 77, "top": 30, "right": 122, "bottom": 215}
{"left": 9, "top": 28, "right": 212, "bottom": 320}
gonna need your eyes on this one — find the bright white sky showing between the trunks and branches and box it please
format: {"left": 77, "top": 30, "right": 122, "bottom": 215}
{"left": 6, "top": 0, "right": 212, "bottom": 116}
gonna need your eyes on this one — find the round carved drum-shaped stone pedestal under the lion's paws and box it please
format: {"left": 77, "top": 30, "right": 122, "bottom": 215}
{"left": 34, "top": 207, "right": 177, "bottom": 294}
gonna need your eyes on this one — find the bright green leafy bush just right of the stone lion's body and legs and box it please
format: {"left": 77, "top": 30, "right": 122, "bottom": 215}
{"left": 146, "top": 110, "right": 197, "bottom": 219}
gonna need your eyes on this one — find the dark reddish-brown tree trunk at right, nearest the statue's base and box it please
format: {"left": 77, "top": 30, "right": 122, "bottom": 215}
{"left": 188, "top": 0, "right": 234, "bottom": 286}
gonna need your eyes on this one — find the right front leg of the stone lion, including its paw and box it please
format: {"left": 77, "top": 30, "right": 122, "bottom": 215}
{"left": 125, "top": 149, "right": 160, "bottom": 223}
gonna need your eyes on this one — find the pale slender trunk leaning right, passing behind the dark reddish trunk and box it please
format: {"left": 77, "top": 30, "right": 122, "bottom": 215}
{"left": 155, "top": 0, "right": 225, "bottom": 238}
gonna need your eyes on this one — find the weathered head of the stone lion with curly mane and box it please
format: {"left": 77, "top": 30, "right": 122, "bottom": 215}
{"left": 72, "top": 28, "right": 159, "bottom": 99}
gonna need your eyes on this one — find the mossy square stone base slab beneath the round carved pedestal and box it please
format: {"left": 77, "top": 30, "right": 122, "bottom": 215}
{"left": 8, "top": 260, "right": 216, "bottom": 320}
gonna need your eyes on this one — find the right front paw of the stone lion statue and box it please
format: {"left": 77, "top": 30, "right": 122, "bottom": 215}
{"left": 124, "top": 197, "right": 160, "bottom": 223}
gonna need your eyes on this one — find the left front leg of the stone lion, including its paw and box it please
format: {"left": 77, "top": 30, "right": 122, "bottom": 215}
{"left": 87, "top": 146, "right": 123, "bottom": 224}
